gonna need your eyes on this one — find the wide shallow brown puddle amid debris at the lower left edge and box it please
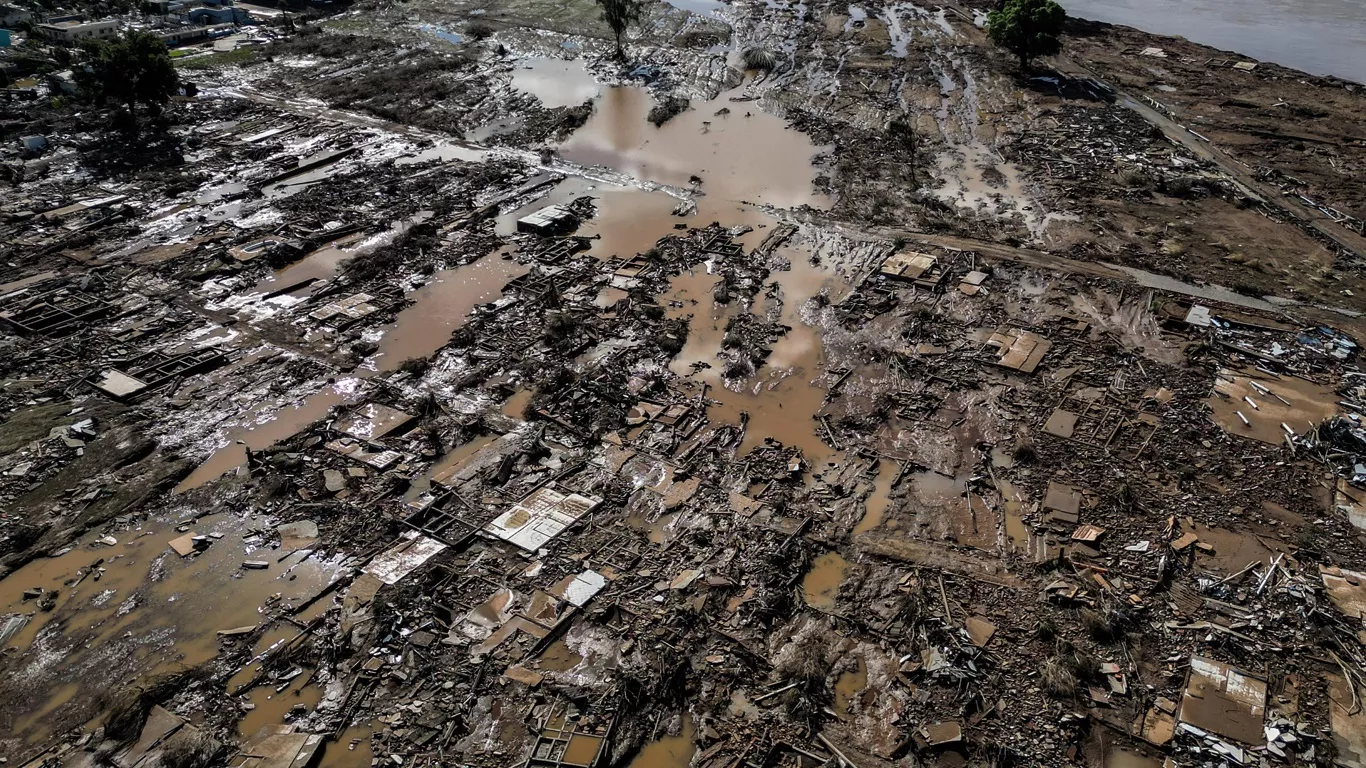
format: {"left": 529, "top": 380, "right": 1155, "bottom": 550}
{"left": 0, "top": 510, "right": 337, "bottom": 743}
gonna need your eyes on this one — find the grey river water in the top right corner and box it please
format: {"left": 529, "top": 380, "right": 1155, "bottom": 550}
{"left": 1061, "top": 0, "right": 1366, "bottom": 83}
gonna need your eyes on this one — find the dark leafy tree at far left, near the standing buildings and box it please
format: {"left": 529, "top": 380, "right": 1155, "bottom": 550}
{"left": 75, "top": 30, "right": 179, "bottom": 126}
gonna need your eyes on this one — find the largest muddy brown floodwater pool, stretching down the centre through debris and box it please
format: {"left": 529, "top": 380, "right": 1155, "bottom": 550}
{"left": 499, "top": 74, "right": 844, "bottom": 462}
